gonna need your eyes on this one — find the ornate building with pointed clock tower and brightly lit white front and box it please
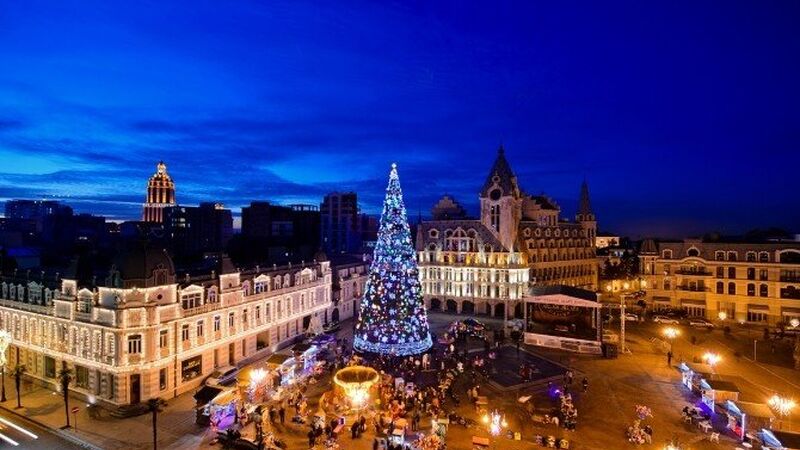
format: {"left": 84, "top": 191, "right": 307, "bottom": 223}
{"left": 416, "top": 147, "right": 597, "bottom": 318}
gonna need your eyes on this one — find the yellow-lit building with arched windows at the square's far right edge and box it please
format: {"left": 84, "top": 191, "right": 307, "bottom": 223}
{"left": 639, "top": 239, "right": 800, "bottom": 324}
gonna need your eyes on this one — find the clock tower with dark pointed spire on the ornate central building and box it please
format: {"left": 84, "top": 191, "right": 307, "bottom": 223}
{"left": 479, "top": 145, "right": 523, "bottom": 250}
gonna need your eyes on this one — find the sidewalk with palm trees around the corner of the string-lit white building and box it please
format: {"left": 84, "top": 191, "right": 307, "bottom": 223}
{"left": 2, "top": 376, "right": 210, "bottom": 450}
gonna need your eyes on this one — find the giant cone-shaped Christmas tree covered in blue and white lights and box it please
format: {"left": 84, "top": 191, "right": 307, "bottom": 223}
{"left": 353, "top": 164, "right": 432, "bottom": 356}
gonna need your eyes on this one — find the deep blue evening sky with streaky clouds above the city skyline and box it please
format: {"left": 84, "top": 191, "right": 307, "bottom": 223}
{"left": 0, "top": 0, "right": 800, "bottom": 237}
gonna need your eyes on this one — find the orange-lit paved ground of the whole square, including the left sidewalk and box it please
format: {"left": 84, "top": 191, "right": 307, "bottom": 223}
{"left": 4, "top": 314, "right": 800, "bottom": 450}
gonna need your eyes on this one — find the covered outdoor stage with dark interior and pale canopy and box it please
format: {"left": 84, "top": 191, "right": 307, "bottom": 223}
{"left": 522, "top": 286, "right": 603, "bottom": 354}
